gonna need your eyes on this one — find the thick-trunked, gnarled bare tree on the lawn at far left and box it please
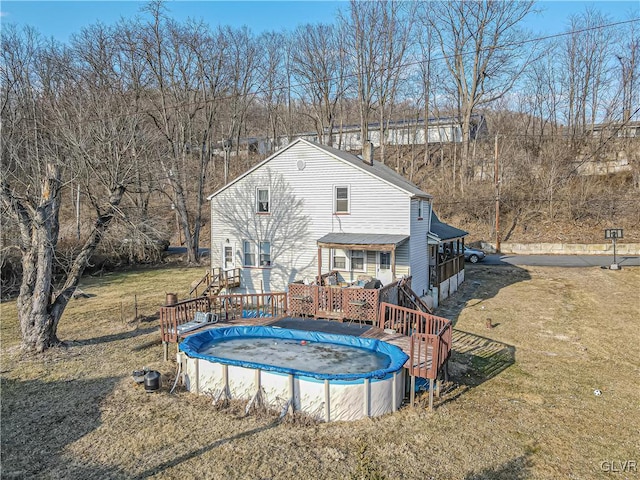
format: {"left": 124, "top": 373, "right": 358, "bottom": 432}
{"left": 0, "top": 27, "right": 136, "bottom": 352}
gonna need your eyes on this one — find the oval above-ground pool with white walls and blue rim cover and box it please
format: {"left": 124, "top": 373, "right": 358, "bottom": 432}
{"left": 179, "top": 327, "right": 408, "bottom": 421}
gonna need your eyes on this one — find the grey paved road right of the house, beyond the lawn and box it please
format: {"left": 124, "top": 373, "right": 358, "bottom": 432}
{"left": 482, "top": 254, "right": 640, "bottom": 268}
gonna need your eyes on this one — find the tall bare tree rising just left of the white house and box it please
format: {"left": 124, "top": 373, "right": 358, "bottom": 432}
{"left": 139, "top": 2, "right": 226, "bottom": 263}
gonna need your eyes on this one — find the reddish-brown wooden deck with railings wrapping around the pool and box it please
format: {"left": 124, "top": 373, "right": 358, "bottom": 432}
{"left": 160, "top": 284, "right": 452, "bottom": 408}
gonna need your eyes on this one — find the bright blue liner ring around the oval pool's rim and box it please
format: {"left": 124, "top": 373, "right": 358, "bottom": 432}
{"left": 180, "top": 327, "right": 409, "bottom": 381}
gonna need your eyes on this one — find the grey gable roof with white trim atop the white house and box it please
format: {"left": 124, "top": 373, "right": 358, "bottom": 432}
{"left": 207, "top": 138, "right": 431, "bottom": 200}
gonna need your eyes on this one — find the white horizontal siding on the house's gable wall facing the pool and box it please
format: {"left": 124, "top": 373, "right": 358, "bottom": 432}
{"left": 211, "top": 142, "right": 410, "bottom": 291}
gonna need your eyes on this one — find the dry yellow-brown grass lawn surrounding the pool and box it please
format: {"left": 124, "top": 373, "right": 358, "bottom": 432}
{"left": 0, "top": 266, "right": 640, "bottom": 479}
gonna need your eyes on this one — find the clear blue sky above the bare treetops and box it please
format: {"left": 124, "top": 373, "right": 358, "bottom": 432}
{"left": 0, "top": 0, "right": 640, "bottom": 42}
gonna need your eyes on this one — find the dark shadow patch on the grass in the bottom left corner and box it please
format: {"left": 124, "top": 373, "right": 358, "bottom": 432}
{"left": 0, "top": 377, "right": 125, "bottom": 479}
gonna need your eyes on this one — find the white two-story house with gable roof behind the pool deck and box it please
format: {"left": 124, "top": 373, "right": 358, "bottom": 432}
{"left": 208, "top": 139, "right": 462, "bottom": 304}
